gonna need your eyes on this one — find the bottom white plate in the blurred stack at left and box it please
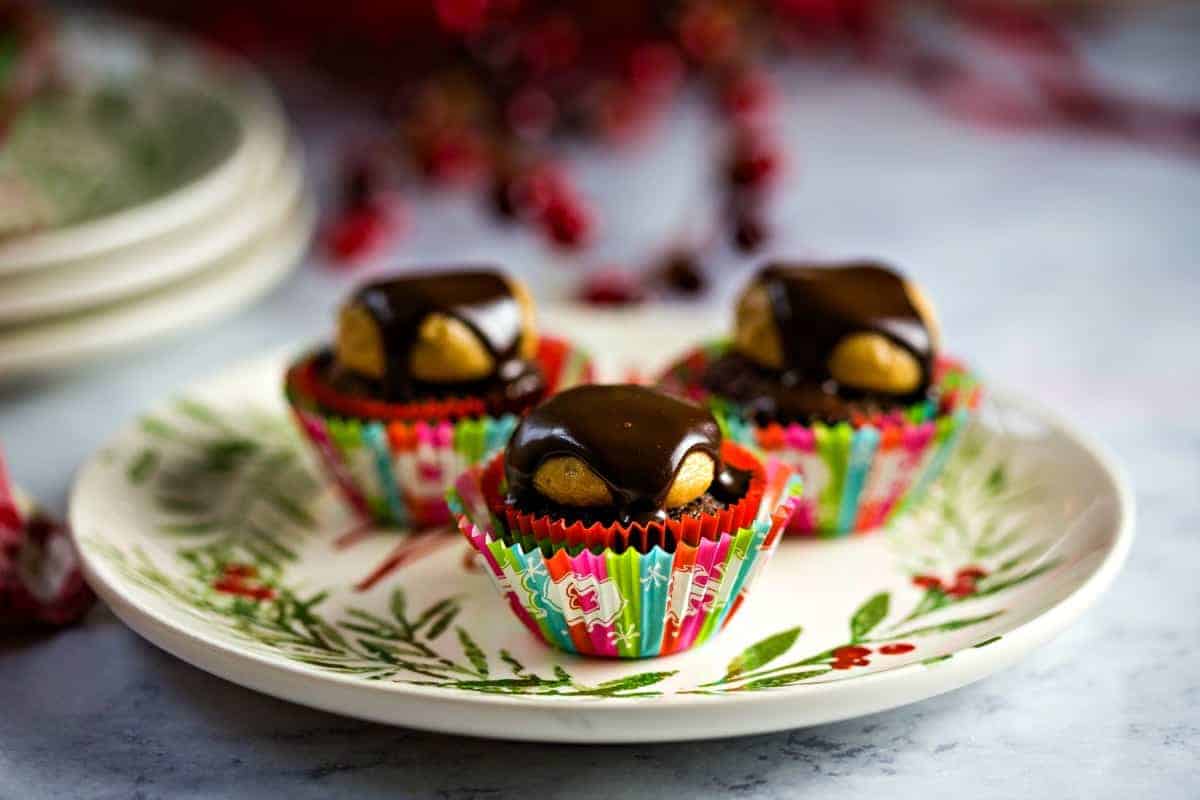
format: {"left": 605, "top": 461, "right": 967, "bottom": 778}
{"left": 0, "top": 197, "right": 316, "bottom": 377}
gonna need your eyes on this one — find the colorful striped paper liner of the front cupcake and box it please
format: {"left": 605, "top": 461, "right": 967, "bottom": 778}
{"left": 448, "top": 450, "right": 800, "bottom": 658}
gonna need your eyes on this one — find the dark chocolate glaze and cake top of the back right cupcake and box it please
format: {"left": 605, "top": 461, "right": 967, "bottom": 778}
{"left": 704, "top": 261, "right": 936, "bottom": 421}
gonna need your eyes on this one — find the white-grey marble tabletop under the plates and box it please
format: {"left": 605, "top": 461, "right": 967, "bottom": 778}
{"left": 0, "top": 12, "right": 1200, "bottom": 800}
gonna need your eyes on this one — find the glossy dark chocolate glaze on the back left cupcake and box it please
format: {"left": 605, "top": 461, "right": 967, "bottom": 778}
{"left": 330, "top": 270, "right": 545, "bottom": 407}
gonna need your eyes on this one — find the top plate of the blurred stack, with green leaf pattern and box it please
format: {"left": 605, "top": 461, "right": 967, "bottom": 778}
{"left": 0, "top": 16, "right": 278, "bottom": 275}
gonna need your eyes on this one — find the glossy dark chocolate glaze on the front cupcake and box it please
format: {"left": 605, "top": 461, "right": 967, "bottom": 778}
{"left": 505, "top": 385, "right": 749, "bottom": 524}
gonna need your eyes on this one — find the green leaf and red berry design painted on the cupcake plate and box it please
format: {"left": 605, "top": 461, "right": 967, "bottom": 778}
{"left": 86, "top": 399, "right": 1057, "bottom": 697}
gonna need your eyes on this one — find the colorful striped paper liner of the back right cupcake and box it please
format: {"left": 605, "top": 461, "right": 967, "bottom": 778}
{"left": 660, "top": 341, "right": 982, "bottom": 537}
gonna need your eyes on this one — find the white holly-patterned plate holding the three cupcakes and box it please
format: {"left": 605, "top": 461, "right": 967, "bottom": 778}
{"left": 71, "top": 335, "right": 1133, "bottom": 744}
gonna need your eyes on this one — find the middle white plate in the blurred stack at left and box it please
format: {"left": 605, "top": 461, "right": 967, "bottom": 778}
{"left": 0, "top": 143, "right": 304, "bottom": 325}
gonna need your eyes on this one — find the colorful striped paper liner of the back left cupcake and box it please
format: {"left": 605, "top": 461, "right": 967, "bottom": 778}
{"left": 286, "top": 337, "right": 593, "bottom": 529}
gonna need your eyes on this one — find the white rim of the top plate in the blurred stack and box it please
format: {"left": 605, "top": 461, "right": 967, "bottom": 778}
{"left": 0, "top": 17, "right": 281, "bottom": 273}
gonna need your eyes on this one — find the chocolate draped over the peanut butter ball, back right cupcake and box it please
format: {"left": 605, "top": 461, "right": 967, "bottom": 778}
{"left": 758, "top": 261, "right": 934, "bottom": 396}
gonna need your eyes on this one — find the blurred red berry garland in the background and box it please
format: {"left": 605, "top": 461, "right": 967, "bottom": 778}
{"left": 114, "top": 0, "right": 1200, "bottom": 296}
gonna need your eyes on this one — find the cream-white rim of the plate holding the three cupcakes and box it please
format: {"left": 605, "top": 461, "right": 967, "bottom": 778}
{"left": 70, "top": 376, "right": 1135, "bottom": 744}
